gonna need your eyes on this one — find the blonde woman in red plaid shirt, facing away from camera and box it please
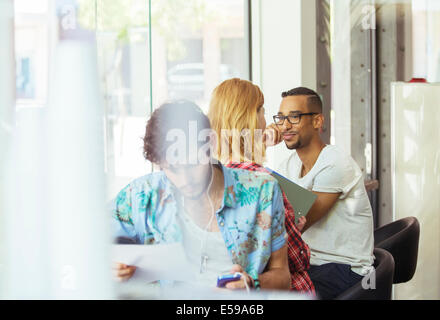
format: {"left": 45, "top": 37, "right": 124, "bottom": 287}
{"left": 208, "top": 78, "right": 315, "bottom": 294}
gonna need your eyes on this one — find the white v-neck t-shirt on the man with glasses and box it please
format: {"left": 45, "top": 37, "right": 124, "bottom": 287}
{"left": 277, "top": 145, "right": 374, "bottom": 275}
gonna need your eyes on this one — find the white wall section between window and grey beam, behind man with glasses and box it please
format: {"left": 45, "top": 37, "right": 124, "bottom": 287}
{"left": 251, "top": 0, "right": 316, "bottom": 167}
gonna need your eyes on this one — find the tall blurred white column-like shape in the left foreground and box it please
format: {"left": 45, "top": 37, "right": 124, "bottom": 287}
{"left": 48, "top": 41, "right": 111, "bottom": 299}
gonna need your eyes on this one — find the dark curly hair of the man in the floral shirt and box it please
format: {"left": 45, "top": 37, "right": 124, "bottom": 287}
{"left": 143, "top": 100, "right": 211, "bottom": 164}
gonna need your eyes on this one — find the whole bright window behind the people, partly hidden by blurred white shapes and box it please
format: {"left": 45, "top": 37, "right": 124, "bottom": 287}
{"left": 14, "top": 0, "right": 250, "bottom": 197}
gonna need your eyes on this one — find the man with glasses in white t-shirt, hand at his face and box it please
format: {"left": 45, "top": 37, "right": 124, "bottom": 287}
{"left": 266, "top": 87, "right": 374, "bottom": 299}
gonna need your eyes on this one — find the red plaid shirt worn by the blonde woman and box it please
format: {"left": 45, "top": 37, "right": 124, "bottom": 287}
{"left": 226, "top": 162, "right": 315, "bottom": 294}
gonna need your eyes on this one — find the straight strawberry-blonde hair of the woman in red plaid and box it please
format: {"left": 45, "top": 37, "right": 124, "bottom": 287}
{"left": 208, "top": 78, "right": 265, "bottom": 164}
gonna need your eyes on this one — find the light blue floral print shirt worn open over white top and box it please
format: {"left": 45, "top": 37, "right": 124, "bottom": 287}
{"left": 112, "top": 165, "right": 285, "bottom": 278}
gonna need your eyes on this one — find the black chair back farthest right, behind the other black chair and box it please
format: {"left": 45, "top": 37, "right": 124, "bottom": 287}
{"left": 374, "top": 217, "right": 420, "bottom": 283}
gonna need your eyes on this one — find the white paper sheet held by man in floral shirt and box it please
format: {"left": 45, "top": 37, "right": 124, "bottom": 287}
{"left": 112, "top": 243, "right": 195, "bottom": 282}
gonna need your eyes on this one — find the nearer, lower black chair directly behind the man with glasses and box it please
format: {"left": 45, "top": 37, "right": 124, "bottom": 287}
{"left": 335, "top": 248, "right": 394, "bottom": 300}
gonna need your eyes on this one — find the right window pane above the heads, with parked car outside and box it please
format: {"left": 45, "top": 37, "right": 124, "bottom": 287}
{"left": 152, "top": 0, "right": 249, "bottom": 111}
